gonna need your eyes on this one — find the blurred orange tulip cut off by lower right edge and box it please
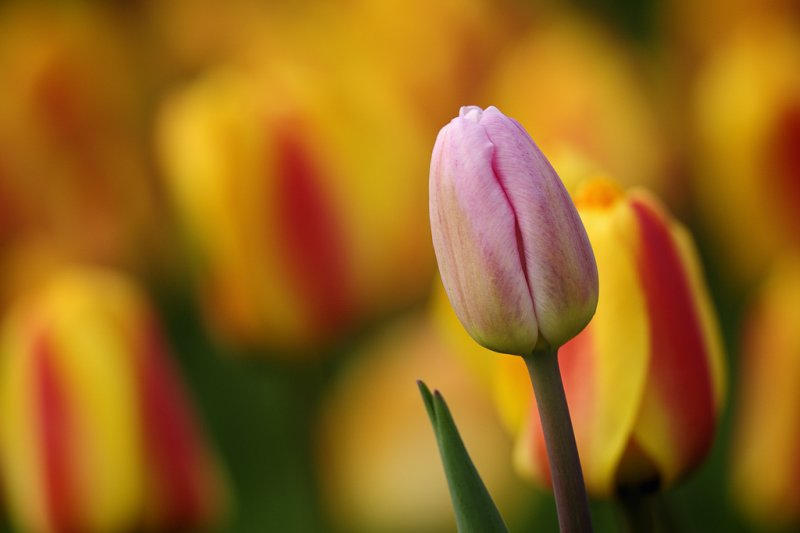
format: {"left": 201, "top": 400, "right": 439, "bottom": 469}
{"left": 731, "top": 256, "right": 800, "bottom": 526}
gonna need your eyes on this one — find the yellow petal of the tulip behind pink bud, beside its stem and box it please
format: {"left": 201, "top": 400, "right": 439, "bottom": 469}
{"left": 516, "top": 198, "right": 649, "bottom": 497}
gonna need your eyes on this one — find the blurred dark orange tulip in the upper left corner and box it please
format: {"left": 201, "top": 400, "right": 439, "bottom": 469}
{"left": 0, "top": 3, "right": 164, "bottom": 268}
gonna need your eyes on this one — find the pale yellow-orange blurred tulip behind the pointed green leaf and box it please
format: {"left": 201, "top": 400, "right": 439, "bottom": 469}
{"left": 319, "top": 317, "right": 521, "bottom": 533}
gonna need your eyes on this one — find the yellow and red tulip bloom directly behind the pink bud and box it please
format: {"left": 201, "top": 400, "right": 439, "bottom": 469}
{"left": 501, "top": 180, "right": 725, "bottom": 497}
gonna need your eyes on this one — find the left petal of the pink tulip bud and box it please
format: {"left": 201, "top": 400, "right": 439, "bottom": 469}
{"left": 430, "top": 118, "right": 538, "bottom": 355}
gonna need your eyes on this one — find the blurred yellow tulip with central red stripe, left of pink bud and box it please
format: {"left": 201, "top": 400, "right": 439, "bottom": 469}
{"left": 159, "top": 58, "right": 433, "bottom": 353}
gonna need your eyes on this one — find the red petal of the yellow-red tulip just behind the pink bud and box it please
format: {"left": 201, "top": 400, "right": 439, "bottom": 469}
{"left": 631, "top": 195, "right": 716, "bottom": 485}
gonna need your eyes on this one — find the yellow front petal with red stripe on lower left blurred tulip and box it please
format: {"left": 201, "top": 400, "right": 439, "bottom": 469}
{"left": 0, "top": 270, "right": 141, "bottom": 531}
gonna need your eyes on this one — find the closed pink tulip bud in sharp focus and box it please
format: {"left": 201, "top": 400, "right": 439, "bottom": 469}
{"left": 430, "top": 106, "right": 597, "bottom": 355}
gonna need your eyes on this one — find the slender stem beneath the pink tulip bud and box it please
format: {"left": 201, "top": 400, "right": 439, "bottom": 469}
{"left": 523, "top": 350, "right": 592, "bottom": 533}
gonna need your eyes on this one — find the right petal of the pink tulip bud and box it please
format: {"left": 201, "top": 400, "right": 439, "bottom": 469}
{"left": 480, "top": 107, "right": 597, "bottom": 346}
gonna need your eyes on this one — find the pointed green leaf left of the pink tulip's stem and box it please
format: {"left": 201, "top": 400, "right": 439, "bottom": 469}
{"left": 417, "top": 381, "right": 508, "bottom": 533}
